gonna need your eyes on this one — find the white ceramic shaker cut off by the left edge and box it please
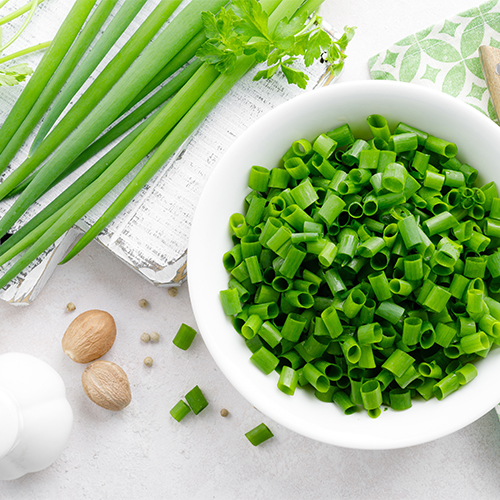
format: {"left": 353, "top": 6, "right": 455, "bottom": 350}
{"left": 0, "top": 353, "right": 73, "bottom": 479}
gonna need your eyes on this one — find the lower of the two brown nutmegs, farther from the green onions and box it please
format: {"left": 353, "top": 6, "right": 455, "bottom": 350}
{"left": 82, "top": 360, "right": 132, "bottom": 411}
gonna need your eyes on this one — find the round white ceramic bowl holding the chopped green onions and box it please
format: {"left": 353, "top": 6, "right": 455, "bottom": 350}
{"left": 188, "top": 81, "right": 500, "bottom": 449}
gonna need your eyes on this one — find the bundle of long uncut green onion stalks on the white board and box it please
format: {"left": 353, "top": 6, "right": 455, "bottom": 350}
{"left": 0, "top": 0, "right": 347, "bottom": 288}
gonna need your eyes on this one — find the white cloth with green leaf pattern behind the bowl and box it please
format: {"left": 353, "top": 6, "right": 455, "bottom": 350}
{"left": 369, "top": 0, "right": 500, "bottom": 122}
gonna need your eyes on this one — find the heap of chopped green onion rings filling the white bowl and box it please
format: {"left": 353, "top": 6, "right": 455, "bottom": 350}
{"left": 220, "top": 115, "right": 500, "bottom": 418}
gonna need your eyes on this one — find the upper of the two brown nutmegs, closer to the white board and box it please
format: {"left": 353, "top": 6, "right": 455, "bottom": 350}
{"left": 62, "top": 309, "right": 116, "bottom": 363}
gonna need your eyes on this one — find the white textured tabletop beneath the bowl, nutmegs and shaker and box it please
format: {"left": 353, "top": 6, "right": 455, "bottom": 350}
{"left": 0, "top": 0, "right": 500, "bottom": 500}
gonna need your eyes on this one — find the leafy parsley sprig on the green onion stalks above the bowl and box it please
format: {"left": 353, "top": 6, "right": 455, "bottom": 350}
{"left": 197, "top": 0, "right": 354, "bottom": 88}
